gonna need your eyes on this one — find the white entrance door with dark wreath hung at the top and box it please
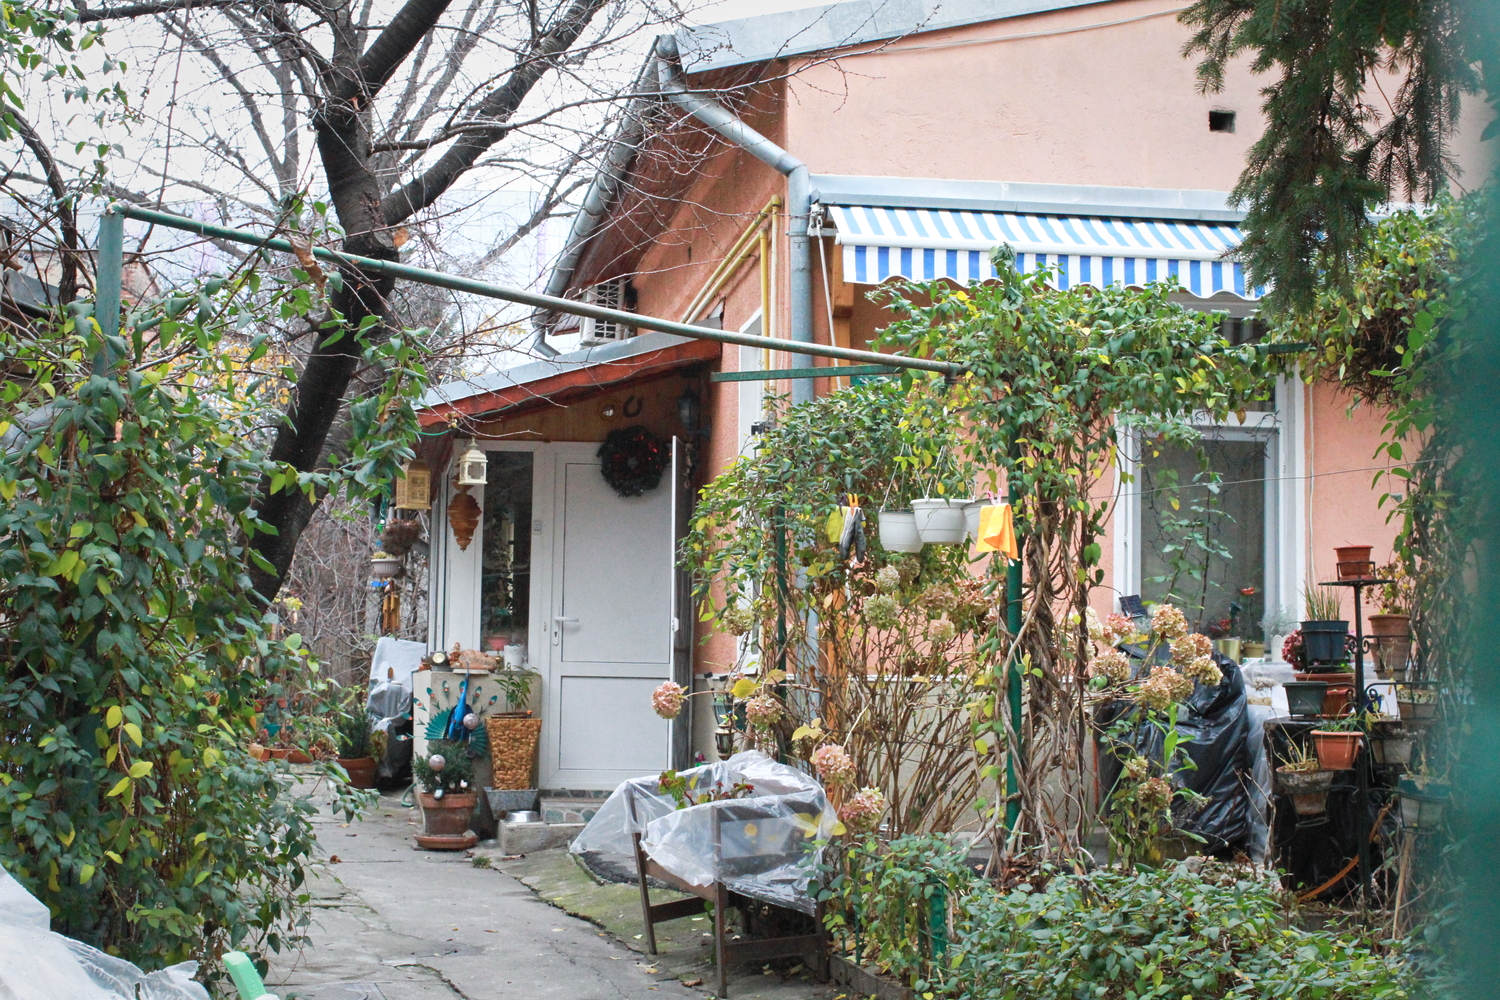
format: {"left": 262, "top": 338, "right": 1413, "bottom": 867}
{"left": 533, "top": 444, "right": 675, "bottom": 789}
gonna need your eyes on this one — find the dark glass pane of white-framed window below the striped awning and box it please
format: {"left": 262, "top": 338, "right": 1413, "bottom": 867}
{"left": 1137, "top": 441, "right": 1266, "bottom": 640}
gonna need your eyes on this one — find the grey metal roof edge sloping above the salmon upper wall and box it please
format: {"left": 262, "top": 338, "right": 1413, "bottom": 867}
{"left": 677, "top": 0, "right": 1107, "bottom": 73}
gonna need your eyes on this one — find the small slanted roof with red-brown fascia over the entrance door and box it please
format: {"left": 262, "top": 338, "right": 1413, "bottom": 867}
{"left": 417, "top": 333, "right": 720, "bottom": 427}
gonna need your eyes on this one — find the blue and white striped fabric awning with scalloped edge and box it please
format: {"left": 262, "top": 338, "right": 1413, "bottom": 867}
{"left": 828, "top": 205, "right": 1262, "bottom": 298}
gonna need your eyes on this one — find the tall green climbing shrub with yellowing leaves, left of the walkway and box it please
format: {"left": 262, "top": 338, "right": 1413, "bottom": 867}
{"left": 0, "top": 274, "right": 410, "bottom": 975}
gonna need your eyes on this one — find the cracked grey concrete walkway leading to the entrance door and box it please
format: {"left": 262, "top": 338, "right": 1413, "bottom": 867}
{"left": 267, "top": 795, "right": 839, "bottom": 1000}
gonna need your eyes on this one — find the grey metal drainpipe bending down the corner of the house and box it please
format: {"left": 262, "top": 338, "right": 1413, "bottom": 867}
{"left": 656, "top": 34, "right": 813, "bottom": 403}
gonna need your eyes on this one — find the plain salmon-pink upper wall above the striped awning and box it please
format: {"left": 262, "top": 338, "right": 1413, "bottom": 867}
{"left": 788, "top": 0, "right": 1262, "bottom": 190}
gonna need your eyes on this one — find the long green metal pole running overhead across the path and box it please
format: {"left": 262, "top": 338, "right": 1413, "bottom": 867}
{"left": 107, "top": 205, "right": 965, "bottom": 376}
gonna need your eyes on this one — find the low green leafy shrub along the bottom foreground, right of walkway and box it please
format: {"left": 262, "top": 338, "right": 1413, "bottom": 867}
{"left": 827, "top": 837, "right": 1419, "bottom": 1000}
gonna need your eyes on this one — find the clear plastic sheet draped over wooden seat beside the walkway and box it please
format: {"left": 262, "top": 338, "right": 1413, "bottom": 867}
{"left": 570, "top": 750, "right": 839, "bottom": 913}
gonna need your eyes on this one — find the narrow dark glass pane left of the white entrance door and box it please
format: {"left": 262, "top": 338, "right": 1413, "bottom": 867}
{"left": 480, "top": 451, "right": 533, "bottom": 649}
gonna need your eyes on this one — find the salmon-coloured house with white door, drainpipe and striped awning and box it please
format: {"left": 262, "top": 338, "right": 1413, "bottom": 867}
{"left": 423, "top": 0, "right": 1464, "bottom": 789}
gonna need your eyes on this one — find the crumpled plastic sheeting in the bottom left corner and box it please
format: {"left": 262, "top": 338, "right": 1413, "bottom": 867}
{"left": 0, "top": 870, "right": 209, "bottom": 1000}
